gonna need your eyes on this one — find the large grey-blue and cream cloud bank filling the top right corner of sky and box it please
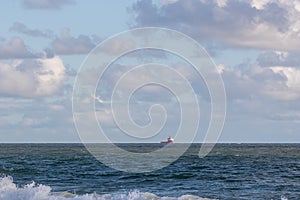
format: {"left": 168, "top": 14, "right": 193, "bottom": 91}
{"left": 133, "top": 0, "right": 300, "bottom": 51}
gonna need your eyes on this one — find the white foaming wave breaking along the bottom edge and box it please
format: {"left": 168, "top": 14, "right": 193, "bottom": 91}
{"left": 0, "top": 176, "right": 213, "bottom": 200}
